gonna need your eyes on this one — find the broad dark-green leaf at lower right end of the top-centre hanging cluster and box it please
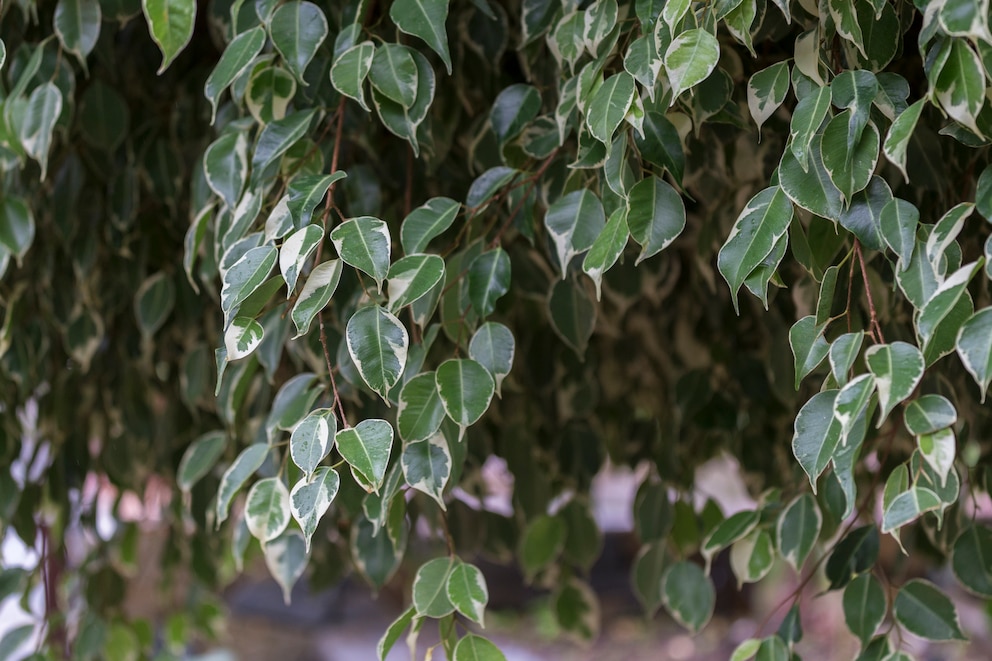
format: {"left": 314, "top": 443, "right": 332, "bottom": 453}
{"left": 627, "top": 175, "right": 685, "bottom": 266}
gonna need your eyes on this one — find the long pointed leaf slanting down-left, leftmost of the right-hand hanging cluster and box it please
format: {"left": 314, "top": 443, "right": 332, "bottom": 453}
{"left": 717, "top": 186, "right": 793, "bottom": 314}
